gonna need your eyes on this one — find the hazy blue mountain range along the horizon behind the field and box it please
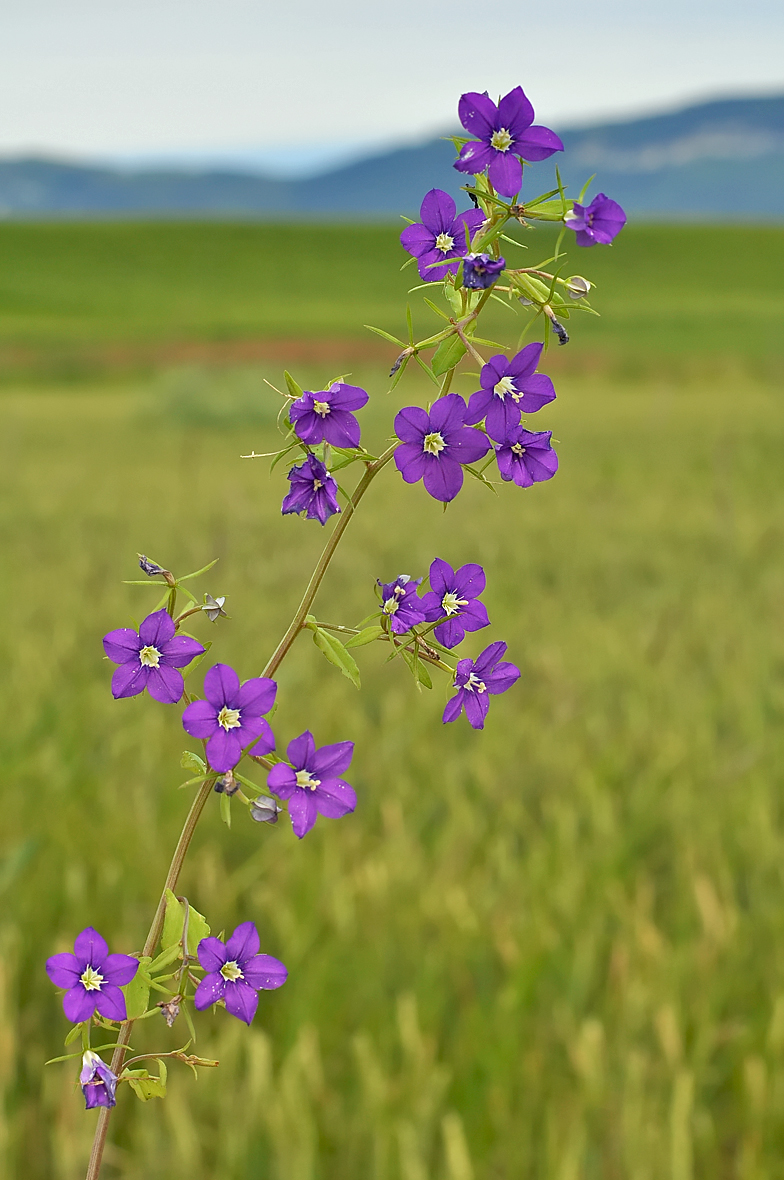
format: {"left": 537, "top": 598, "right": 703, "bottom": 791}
{"left": 0, "top": 94, "right": 784, "bottom": 219}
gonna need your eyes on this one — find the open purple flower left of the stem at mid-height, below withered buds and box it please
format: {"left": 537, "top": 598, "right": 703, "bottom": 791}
{"left": 104, "top": 610, "right": 204, "bottom": 704}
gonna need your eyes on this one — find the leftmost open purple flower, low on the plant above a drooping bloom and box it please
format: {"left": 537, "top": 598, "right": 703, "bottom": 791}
{"left": 46, "top": 926, "right": 139, "bottom": 1024}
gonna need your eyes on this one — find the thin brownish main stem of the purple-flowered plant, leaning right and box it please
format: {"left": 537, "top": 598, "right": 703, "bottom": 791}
{"left": 85, "top": 443, "right": 397, "bottom": 1180}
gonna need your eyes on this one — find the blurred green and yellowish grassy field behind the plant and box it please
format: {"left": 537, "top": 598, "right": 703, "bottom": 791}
{"left": 0, "top": 225, "right": 784, "bottom": 1180}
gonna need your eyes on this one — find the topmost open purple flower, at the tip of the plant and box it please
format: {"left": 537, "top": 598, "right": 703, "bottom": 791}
{"left": 455, "top": 86, "right": 563, "bottom": 197}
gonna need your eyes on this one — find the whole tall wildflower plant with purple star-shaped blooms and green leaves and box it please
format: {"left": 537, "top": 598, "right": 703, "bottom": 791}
{"left": 46, "top": 78, "right": 626, "bottom": 1180}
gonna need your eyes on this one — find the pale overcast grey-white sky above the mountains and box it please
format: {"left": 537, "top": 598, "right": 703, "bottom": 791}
{"left": 0, "top": 0, "right": 784, "bottom": 168}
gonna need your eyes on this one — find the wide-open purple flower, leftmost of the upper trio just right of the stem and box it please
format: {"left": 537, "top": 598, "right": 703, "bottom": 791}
{"left": 394, "top": 393, "right": 490, "bottom": 504}
